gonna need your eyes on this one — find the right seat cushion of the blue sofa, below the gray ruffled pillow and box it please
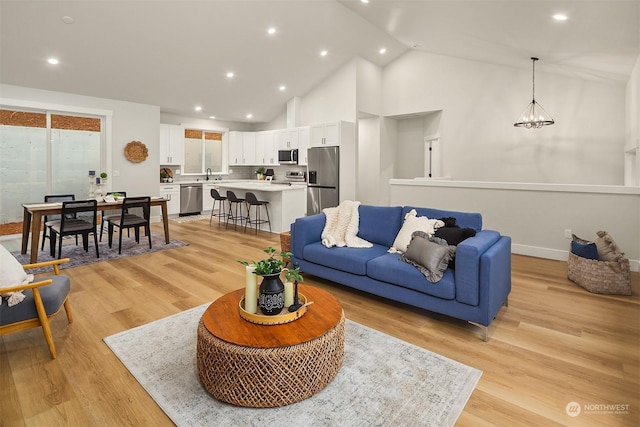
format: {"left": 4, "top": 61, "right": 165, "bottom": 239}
{"left": 367, "top": 253, "right": 456, "bottom": 300}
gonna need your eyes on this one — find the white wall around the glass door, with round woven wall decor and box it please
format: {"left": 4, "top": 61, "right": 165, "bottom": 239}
{"left": 0, "top": 84, "right": 160, "bottom": 200}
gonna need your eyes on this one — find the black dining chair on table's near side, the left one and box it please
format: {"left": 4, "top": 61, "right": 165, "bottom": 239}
{"left": 49, "top": 200, "right": 100, "bottom": 258}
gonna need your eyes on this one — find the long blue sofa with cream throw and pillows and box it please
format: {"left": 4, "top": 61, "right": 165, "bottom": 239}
{"left": 291, "top": 205, "right": 511, "bottom": 341}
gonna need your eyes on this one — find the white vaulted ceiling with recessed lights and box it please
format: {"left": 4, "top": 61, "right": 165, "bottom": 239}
{"left": 0, "top": 0, "right": 640, "bottom": 122}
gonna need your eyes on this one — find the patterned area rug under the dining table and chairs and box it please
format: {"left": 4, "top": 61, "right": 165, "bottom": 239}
{"left": 11, "top": 232, "right": 187, "bottom": 274}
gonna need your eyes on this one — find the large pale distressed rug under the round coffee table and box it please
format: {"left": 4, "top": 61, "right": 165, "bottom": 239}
{"left": 104, "top": 304, "right": 482, "bottom": 427}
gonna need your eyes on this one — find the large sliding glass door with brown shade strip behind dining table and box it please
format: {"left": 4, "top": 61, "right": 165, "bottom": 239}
{"left": 0, "top": 109, "right": 104, "bottom": 224}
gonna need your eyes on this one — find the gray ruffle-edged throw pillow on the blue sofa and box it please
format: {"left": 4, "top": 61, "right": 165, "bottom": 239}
{"left": 400, "top": 231, "right": 456, "bottom": 283}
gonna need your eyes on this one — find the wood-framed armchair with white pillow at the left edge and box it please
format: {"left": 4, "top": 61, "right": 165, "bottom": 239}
{"left": 0, "top": 245, "right": 73, "bottom": 359}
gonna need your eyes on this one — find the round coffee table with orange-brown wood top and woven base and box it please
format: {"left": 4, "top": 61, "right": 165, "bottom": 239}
{"left": 196, "top": 285, "right": 344, "bottom": 408}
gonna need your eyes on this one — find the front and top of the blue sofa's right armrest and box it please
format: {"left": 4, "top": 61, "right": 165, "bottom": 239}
{"left": 455, "top": 230, "right": 500, "bottom": 306}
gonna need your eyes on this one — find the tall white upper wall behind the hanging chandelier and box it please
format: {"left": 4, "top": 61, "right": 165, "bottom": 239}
{"left": 383, "top": 51, "right": 625, "bottom": 185}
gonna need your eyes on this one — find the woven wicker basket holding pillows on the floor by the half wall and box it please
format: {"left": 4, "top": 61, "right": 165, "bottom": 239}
{"left": 567, "top": 252, "right": 631, "bottom": 295}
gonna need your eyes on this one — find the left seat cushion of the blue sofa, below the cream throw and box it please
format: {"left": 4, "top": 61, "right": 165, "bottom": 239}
{"left": 302, "top": 242, "right": 387, "bottom": 276}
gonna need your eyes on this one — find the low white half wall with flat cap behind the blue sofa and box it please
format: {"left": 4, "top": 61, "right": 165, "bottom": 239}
{"left": 391, "top": 180, "right": 640, "bottom": 271}
